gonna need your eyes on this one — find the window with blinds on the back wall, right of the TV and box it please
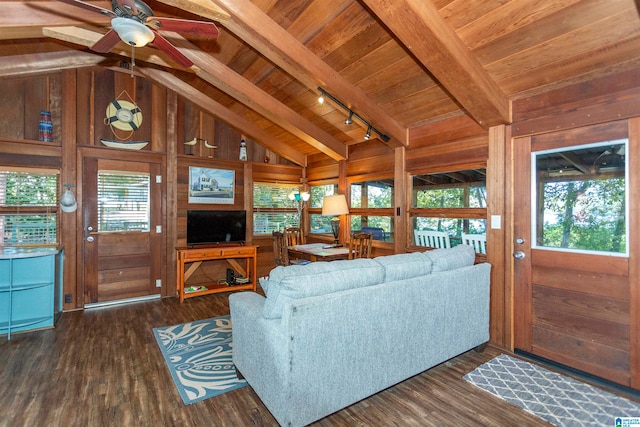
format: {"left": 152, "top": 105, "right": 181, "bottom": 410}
{"left": 253, "top": 182, "right": 300, "bottom": 234}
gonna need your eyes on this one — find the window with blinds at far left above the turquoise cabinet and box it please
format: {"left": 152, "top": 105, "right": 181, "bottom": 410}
{"left": 0, "top": 168, "right": 58, "bottom": 246}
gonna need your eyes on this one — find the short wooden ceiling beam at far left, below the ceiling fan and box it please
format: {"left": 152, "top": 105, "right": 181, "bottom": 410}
{"left": 0, "top": 51, "right": 106, "bottom": 77}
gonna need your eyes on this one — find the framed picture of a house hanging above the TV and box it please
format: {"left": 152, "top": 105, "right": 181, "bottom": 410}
{"left": 189, "top": 166, "right": 235, "bottom": 205}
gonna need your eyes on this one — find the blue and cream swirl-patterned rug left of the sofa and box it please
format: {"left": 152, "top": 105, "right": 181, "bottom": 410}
{"left": 153, "top": 316, "right": 247, "bottom": 405}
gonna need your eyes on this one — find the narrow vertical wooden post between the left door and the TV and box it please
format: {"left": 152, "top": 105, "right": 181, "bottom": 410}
{"left": 162, "top": 91, "right": 179, "bottom": 296}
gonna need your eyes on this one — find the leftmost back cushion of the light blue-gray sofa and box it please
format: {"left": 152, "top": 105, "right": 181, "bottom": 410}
{"left": 263, "top": 258, "right": 384, "bottom": 319}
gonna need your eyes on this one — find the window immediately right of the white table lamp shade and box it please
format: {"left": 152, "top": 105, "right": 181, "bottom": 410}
{"left": 349, "top": 179, "right": 395, "bottom": 242}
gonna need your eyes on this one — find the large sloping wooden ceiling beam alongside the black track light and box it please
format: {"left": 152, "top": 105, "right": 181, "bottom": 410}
{"left": 158, "top": 0, "right": 408, "bottom": 146}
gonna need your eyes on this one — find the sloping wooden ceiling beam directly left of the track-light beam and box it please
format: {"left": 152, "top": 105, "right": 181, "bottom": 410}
{"left": 170, "top": 33, "right": 347, "bottom": 160}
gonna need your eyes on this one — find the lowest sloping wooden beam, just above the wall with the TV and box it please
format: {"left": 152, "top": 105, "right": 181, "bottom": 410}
{"left": 137, "top": 67, "right": 307, "bottom": 166}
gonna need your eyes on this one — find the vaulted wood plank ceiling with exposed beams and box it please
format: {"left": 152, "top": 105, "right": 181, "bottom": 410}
{"left": 0, "top": 0, "right": 640, "bottom": 163}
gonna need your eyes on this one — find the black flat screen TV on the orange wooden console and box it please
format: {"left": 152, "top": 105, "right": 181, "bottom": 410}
{"left": 187, "top": 210, "right": 247, "bottom": 246}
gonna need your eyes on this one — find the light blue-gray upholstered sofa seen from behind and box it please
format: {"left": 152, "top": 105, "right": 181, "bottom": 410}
{"left": 229, "top": 246, "right": 491, "bottom": 426}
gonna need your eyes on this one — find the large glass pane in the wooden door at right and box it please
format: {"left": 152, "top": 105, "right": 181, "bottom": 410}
{"left": 532, "top": 139, "right": 628, "bottom": 254}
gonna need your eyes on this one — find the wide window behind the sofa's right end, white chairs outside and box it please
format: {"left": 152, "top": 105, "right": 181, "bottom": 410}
{"left": 410, "top": 168, "right": 487, "bottom": 251}
